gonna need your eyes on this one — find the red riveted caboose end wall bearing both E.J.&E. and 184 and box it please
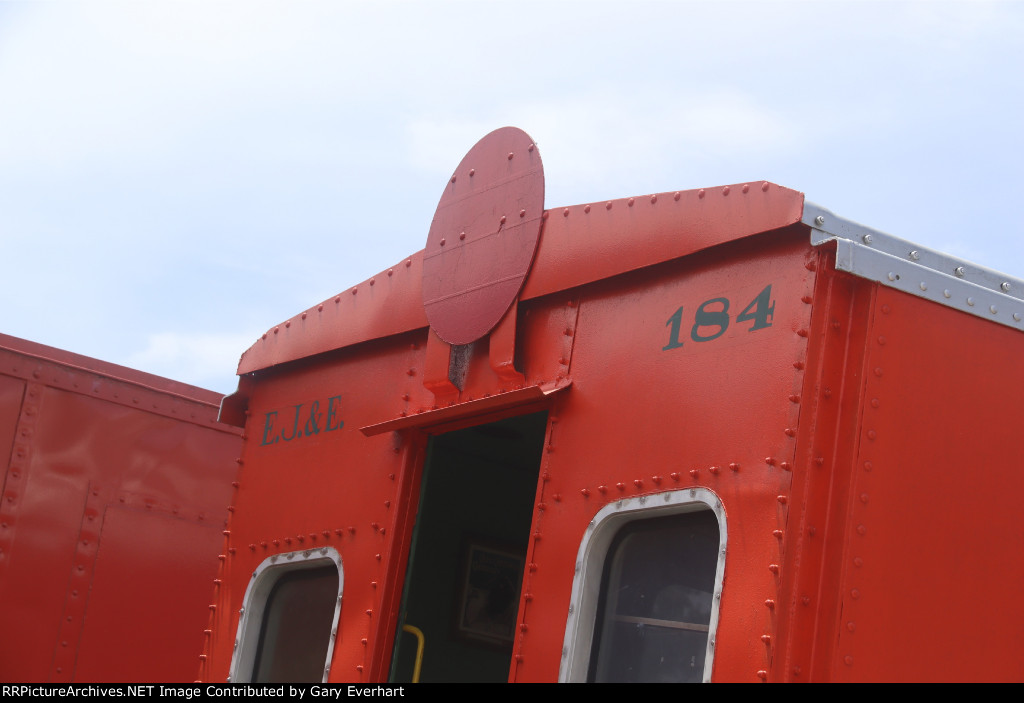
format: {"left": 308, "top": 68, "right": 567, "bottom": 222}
{"left": 201, "top": 228, "right": 817, "bottom": 682}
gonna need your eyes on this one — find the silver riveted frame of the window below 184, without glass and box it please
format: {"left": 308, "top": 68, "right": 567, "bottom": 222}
{"left": 558, "top": 488, "right": 728, "bottom": 683}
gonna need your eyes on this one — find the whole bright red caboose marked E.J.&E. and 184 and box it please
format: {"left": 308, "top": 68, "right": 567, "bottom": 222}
{"left": 201, "top": 128, "right": 1024, "bottom": 682}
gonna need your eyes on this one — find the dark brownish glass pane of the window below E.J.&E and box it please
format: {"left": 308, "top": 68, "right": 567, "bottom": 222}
{"left": 253, "top": 565, "right": 338, "bottom": 684}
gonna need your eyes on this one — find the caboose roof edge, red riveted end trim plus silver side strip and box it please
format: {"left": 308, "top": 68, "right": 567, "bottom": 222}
{"left": 238, "top": 181, "right": 1024, "bottom": 376}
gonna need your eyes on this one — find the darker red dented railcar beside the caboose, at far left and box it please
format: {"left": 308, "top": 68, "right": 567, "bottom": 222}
{"left": 0, "top": 336, "right": 241, "bottom": 682}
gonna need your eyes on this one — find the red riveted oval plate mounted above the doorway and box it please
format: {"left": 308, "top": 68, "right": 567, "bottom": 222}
{"left": 423, "top": 127, "right": 544, "bottom": 344}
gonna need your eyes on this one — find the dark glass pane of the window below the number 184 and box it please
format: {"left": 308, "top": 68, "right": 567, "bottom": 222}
{"left": 588, "top": 511, "right": 719, "bottom": 682}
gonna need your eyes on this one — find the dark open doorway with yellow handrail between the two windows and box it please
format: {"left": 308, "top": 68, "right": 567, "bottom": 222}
{"left": 391, "top": 412, "right": 547, "bottom": 683}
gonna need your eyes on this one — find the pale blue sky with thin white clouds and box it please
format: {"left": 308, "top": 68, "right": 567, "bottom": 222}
{"left": 0, "top": 0, "right": 1024, "bottom": 393}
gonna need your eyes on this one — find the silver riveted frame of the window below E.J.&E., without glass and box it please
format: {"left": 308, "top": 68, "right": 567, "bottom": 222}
{"left": 227, "top": 546, "right": 345, "bottom": 684}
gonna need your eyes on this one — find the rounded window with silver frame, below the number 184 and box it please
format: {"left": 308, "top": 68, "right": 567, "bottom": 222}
{"left": 560, "top": 488, "right": 725, "bottom": 682}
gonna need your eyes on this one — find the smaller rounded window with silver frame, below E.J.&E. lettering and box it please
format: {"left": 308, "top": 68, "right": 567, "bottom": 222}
{"left": 230, "top": 547, "right": 342, "bottom": 683}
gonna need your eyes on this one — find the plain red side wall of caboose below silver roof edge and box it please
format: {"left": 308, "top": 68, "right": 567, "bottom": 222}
{"left": 831, "top": 288, "right": 1024, "bottom": 680}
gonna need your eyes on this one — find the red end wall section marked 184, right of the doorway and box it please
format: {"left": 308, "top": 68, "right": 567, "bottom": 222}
{"left": 514, "top": 231, "right": 813, "bottom": 682}
